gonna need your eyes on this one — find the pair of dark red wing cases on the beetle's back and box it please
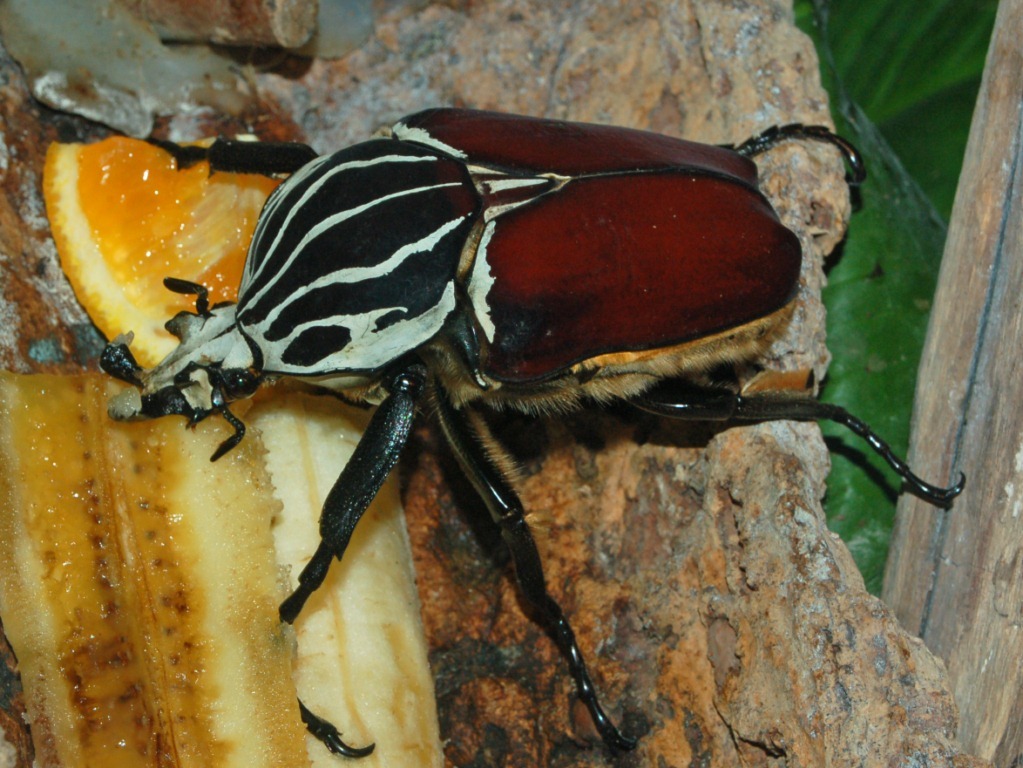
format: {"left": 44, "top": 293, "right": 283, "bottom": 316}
{"left": 403, "top": 109, "right": 801, "bottom": 381}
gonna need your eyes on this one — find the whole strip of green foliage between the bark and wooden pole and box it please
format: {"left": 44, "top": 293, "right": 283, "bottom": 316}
{"left": 796, "top": 0, "right": 996, "bottom": 592}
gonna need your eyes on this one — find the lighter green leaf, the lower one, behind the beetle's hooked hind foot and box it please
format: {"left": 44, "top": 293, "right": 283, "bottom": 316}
{"left": 822, "top": 115, "right": 945, "bottom": 591}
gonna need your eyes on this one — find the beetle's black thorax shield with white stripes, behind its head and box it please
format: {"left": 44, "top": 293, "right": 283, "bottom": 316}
{"left": 237, "top": 139, "right": 480, "bottom": 375}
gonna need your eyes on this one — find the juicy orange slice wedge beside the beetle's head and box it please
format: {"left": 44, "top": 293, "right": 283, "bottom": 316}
{"left": 43, "top": 137, "right": 279, "bottom": 367}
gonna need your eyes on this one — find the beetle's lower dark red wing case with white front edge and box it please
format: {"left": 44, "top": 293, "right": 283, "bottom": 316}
{"left": 470, "top": 169, "right": 801, "bottom": 381}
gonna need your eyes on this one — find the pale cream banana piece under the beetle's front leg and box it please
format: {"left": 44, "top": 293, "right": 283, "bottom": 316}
{"left": 246, "top": 393, "right": 444, "bottom": 768}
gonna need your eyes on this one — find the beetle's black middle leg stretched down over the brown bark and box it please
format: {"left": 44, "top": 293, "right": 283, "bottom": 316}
{"left": 437, "top": 387, "right": 636, "bottom": 752}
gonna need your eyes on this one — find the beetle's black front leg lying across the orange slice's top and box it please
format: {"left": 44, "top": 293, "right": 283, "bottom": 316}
{"left": 149, "top": 139, "right": 317, "bottom": 176}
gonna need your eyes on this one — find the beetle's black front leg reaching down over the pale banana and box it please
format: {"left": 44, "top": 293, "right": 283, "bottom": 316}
{"left": 280, "top": 361, "right": 426, "bottom": 758}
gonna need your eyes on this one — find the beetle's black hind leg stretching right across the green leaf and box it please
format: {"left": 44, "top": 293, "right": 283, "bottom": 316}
{"left": 632, "top": 381, "right": 966, "bottom": 506}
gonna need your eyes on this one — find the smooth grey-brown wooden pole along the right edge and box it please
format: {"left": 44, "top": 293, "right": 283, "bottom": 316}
{"left": 884, "top": 0, "right": 1023, "bottom": 766}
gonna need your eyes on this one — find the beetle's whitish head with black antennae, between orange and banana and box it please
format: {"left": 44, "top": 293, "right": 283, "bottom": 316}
{"left": 99, "top": 290, "right": 261, "bottom": 459}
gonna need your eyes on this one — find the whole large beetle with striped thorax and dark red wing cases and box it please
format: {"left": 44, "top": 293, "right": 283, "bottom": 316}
{"left": 100, "top": 108, "right": 965, "bottom": 757}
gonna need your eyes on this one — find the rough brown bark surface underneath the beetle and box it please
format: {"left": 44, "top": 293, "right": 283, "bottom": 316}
{"left": 0, "top": 0, "right": 981, "bottom": 768}
